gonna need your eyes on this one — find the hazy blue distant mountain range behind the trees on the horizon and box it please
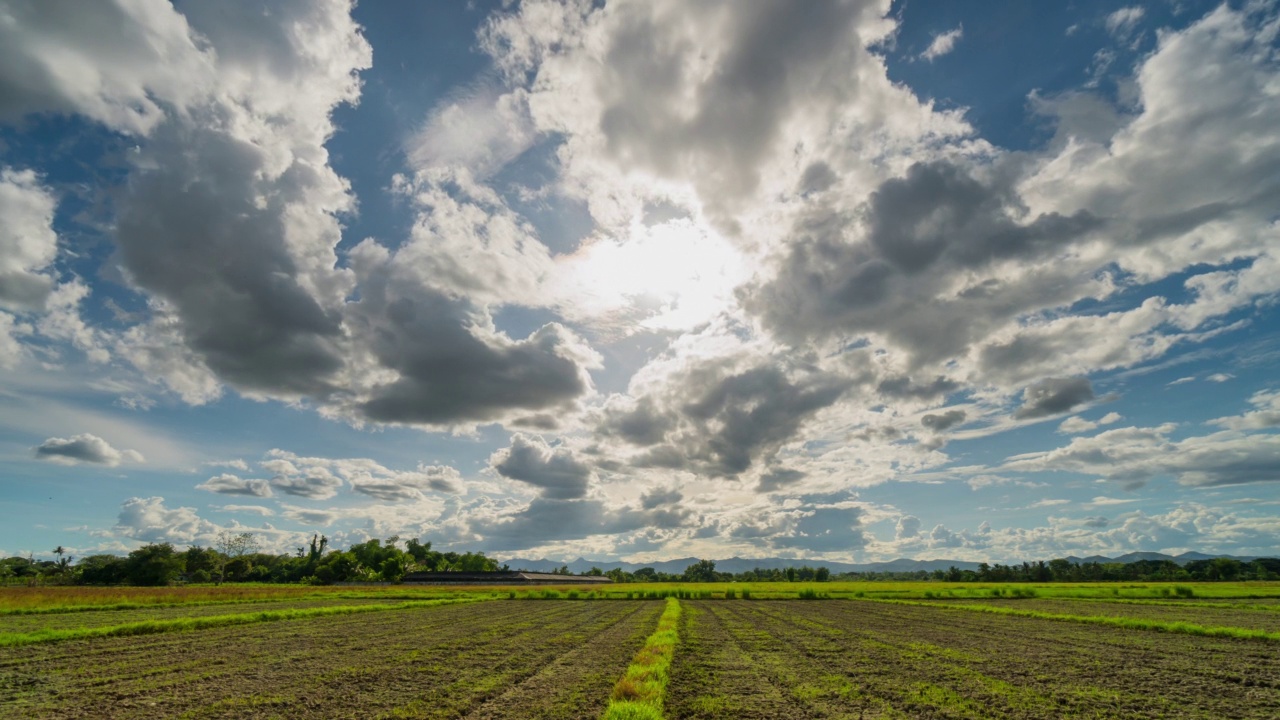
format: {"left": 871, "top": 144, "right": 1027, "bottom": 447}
{"left": 503, "top": 552, "right": 1257, "bottom": 575}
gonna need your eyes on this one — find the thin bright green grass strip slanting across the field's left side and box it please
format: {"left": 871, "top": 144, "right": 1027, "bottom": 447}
{"left": 0, "top": 600, "right": 476, "bottom": 647}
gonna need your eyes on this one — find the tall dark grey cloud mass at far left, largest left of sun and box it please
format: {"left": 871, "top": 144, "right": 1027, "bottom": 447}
{"left": 116, "top": 124, "right": 342, "bottom": 397}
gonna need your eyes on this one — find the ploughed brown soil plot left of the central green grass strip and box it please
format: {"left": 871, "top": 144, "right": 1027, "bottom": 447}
{"left": 0, "top": 602, "right": 662, "bottom": 719}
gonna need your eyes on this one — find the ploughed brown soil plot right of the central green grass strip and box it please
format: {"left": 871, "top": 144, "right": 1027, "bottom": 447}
{"left": 668, "top": 601, "right": 1280, "bottom": 720}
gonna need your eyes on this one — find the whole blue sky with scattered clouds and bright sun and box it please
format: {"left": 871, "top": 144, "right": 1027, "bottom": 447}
{"left": 0, "top": 0, "right": 1280, "bottom": 562}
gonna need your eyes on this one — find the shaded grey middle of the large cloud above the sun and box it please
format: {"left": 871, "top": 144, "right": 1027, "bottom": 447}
{"left": 599, "top": 0, "right": 873, "bottom": 212}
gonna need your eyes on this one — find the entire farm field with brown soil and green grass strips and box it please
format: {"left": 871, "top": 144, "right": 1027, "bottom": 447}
{"left": 0, "top": 583, "right": 1280, "bottom": 719}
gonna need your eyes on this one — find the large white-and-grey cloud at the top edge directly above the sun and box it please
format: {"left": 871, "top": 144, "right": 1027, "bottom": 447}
{"left": 480, "top": 1, "right": 966, "bottom": 229}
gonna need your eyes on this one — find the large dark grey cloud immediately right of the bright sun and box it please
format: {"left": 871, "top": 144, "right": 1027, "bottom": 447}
{"left": 740, "top": 161, "right": 1101, "bottom": 364}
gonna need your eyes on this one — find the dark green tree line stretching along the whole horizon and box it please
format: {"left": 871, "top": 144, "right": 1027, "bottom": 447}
{"left": 0, "top": 532, "right": 1280, "bottom": 585}
